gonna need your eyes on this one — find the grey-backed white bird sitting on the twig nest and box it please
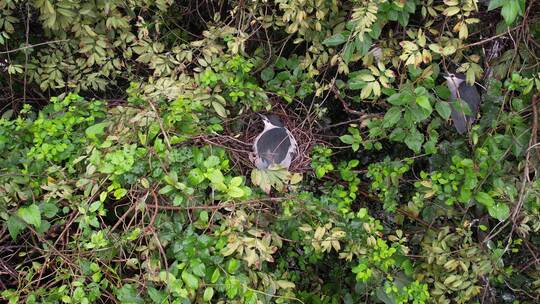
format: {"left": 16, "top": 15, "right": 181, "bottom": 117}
{"left": 253, "top": 113, "right": 298, "bottom": 170}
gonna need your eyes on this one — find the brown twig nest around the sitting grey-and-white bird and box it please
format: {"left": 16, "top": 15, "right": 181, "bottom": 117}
{"left": 203, "top": 100, "right": 318, "bottom": 175}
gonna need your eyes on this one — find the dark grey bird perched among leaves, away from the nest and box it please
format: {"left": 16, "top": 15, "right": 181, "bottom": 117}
{"left": 444, "top": 73, "right": 480, "bottom": 134}
